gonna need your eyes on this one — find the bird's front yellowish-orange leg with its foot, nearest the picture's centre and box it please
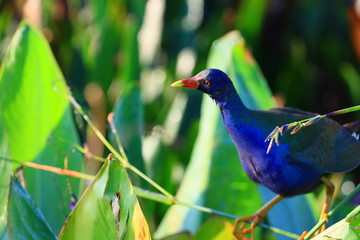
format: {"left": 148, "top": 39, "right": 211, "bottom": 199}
{"left": 233, "top": 195, "right": 284, "bottom": 240}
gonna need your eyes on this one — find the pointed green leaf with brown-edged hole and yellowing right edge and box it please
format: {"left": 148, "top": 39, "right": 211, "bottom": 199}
{"left": 59, "top": 158, "right": 150, "bottom": 240}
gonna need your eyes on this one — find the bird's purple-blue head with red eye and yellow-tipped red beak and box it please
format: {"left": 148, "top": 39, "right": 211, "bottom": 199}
{"left": 171, "top": 68, "right": 234, "bottom": 100}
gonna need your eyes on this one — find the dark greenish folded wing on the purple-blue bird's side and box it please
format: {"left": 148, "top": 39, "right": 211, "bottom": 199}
{"left": 262, "top": 108, "right": 360, "bottom": 173}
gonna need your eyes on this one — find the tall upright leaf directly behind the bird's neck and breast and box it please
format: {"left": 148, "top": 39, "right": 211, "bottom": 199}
{"left": 156, "top": 32, "right": 314, "bottom": 237}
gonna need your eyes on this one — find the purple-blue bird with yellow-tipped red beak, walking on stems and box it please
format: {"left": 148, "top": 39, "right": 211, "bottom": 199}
{"left": 171, "top": 68, "right": 360, "bottom": 240}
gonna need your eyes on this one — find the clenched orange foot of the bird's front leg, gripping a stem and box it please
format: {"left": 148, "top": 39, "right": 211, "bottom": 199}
{"left": 233, "top": 214, "right": 262, "bottom": 240}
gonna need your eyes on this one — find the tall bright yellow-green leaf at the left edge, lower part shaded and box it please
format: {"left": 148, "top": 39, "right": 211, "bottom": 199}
{"left": 0, "top": 23, "right": 82, "bottom": 231}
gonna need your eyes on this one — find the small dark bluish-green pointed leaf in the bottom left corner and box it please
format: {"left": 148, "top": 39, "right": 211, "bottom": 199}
{"left": 7, "top": 178, "right": 56, "bottom": 240}
